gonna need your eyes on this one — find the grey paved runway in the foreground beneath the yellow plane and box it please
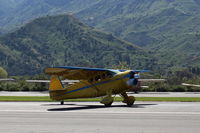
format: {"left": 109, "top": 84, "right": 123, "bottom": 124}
{"left": 0, "top": 102, "right": 200, "bottom": 133}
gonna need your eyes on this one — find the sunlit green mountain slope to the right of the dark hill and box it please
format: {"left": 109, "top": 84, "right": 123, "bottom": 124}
{"left": 77, "top": 0, "right": 200, "bottom": 69}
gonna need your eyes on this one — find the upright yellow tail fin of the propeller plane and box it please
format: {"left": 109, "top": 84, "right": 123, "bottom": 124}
{"left": 49, "top": 75, "right": 64, "bottom": 91}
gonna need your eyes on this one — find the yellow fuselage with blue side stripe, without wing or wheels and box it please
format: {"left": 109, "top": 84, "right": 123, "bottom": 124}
{"left": 49, "top": 71, "right": 130, "bottom": 100}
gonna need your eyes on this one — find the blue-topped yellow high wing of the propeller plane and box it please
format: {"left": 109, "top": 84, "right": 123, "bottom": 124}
{"left": 45, "top": 66, "right": 146, "bottom": 80}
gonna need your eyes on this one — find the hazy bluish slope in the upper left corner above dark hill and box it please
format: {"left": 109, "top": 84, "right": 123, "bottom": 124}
{"left": 0, "top": 0, "right": 99, "bottom": 33}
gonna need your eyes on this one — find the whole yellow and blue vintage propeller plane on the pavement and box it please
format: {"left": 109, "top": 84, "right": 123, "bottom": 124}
{"left": 45, "top": 66, "right": 164, "bottom": 106}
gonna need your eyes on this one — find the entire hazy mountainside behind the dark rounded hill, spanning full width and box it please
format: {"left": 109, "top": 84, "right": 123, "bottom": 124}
{"left": 0, "top": 0, "right": 200, "bottom": 74}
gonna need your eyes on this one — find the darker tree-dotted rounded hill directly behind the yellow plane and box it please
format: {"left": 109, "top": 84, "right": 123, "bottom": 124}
{"left": 0, "top": 15, "right": 153, "bottom": 75}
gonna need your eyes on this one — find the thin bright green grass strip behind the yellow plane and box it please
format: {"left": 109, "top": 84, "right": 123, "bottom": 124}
{"left": 0, "top": 96, "right": 200, "bottom": 102}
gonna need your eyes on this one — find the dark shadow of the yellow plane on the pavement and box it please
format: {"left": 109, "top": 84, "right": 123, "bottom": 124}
{"left": 47, "top": 104, "right": 157, "bottom": 111}
